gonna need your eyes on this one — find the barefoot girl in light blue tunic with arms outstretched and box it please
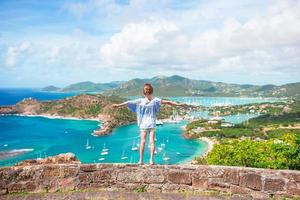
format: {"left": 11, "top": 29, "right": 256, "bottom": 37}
{"left": 113, "top": 83, "right": 186, "bottom": 164}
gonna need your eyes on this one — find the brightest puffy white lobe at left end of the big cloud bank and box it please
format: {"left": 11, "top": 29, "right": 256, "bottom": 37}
{"left": 100, "top": 20, "right": 178, "bottom": 66}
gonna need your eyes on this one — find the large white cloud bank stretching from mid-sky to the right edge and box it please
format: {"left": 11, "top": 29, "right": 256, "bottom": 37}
{"left": 100, "top": 1, "right": 300, "bottom": 76}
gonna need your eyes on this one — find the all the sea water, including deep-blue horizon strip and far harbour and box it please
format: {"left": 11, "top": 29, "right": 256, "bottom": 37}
{"left": 0, "top": 89, "right": 276, "bottom": 166}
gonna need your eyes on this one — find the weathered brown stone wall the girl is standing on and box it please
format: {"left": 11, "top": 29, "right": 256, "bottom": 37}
{"left": 0, "top": 163, "right": 300, "bottom": 198}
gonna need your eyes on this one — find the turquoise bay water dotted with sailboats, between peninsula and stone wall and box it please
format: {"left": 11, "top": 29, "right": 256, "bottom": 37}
{"left": 0, "top": 116, "right": 207, "bottom": 166}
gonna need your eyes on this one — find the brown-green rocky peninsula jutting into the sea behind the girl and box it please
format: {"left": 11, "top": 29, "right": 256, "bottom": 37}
{"left": 0, "top": 94, "right": 194, "bottom": 136}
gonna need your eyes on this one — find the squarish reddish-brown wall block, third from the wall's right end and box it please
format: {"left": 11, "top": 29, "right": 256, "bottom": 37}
{"left": 240, "top": 173, "right": 262, "bottom": 190}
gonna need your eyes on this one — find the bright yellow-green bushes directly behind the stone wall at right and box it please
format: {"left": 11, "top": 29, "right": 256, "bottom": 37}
{"left": 197, "top": 133, "right": 300, "bottom": 170}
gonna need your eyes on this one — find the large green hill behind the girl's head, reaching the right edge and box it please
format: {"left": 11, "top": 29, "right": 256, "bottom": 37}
{"left": 104, "top": 75, "right": 300, "bottom": 97}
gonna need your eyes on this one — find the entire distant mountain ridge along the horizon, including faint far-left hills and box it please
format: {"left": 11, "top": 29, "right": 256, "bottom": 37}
{"left": 43, "top": 75, "right": 300, "bottom": 98}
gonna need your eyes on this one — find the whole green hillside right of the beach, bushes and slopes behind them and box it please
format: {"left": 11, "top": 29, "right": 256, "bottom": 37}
{"left": 192, "top": 101, "right": 300, "bottom": 170}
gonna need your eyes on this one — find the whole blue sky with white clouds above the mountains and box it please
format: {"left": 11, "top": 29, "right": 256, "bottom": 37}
{"left": 0, "top": 0, "right": 300, "bottom": 87}
